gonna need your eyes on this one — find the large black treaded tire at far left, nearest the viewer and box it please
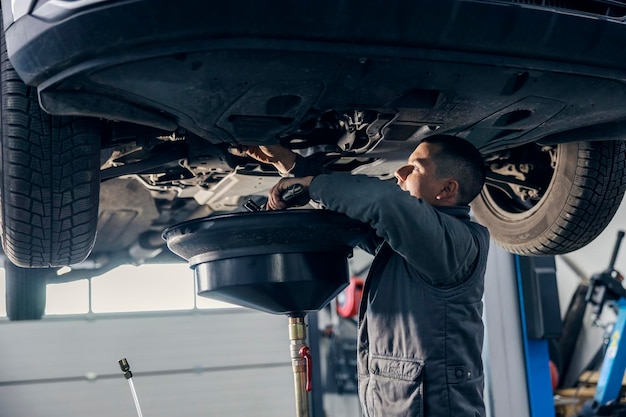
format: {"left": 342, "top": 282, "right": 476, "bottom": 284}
{"left": 0, "top": 28, "right": 100, "bottom": 268}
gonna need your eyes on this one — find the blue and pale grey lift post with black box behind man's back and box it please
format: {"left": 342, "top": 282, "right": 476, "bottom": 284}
{"left": 484, "top": 243, "right": 561, "bottom": 417}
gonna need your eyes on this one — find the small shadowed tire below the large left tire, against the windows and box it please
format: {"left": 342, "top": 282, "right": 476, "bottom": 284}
{"left": 4, "top": 260, "right": 49, "bottom": 321}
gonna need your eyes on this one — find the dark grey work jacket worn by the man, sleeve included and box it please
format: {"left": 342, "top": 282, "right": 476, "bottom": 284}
{"left": 310, "top": 174, "right": 489, "bottom": 417}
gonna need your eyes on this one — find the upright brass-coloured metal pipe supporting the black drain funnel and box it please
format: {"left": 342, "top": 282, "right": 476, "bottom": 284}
{"left": 289, "top": 315, "right": 311, "bottom": 417}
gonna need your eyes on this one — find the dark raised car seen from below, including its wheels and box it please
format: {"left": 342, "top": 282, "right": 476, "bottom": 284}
{"left": 0, "top": 0, "right": 626, "bottom": 318}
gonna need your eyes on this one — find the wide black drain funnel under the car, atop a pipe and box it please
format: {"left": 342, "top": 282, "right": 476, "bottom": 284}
{"left": 163, "top": 209, "right": 368, "bottom": 315}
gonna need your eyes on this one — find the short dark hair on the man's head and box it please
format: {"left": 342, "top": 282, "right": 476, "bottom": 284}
{"left": 422, "top": 135, "right": 485, "bottom": 205}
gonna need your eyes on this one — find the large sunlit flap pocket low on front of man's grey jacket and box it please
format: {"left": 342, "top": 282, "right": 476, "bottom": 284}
{"left": 363, "top": 355, "right": 424, "bottom": 417}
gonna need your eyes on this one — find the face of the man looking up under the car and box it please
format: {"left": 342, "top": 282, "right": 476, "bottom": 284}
{"left": 395, "top": 143, "right": 445, "bottom": 205}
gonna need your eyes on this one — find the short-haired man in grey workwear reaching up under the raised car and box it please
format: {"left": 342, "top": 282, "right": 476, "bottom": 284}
{"left": 246, "top": 135, "right": 489, "bottom": 417}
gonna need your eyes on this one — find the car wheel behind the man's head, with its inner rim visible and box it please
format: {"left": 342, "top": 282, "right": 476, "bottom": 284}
{"left": 472, "top": 141, "right": 626, "bottom": 255}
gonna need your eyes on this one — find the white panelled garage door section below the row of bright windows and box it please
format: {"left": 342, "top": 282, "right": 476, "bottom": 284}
{"left": 0, "top": 309, "right": 295, "bottom": 417}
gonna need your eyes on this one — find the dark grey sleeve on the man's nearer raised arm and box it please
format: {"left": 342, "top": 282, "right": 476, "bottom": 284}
{"left": 309, "top": 173, "right": 478, "bottom": 286}
